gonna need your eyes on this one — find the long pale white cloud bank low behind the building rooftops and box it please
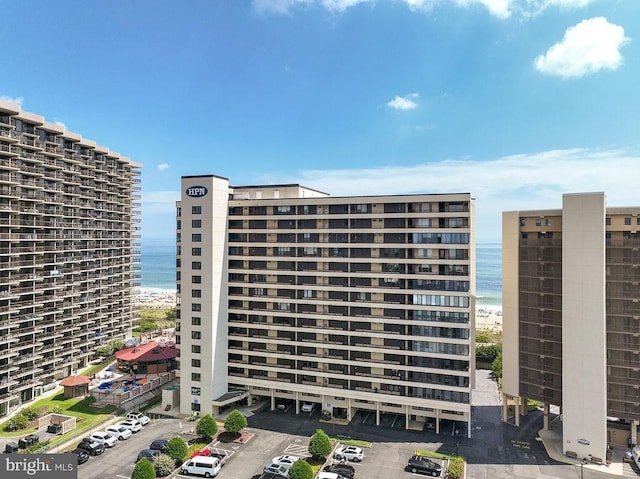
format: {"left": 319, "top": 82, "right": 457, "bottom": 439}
{"left": 252, "top": 148, "right": 640, "bottom": 242}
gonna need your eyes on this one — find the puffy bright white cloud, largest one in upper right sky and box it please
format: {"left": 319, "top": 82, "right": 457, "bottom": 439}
{"left": 534, "top": 17, "right": 630, "bottom": 78}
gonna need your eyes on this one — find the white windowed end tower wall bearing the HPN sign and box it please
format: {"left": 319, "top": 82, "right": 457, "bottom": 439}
{"left": 178, "top": 176, "right": 229, "bottom": 414}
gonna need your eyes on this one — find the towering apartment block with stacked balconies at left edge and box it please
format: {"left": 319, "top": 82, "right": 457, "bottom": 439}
{"left": 0, "top": 101, "right": 140, "bottom": 416}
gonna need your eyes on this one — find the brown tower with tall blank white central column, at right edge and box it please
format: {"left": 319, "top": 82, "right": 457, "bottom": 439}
{"left": 502, "top": 193, "right": 640, "bottom": 464}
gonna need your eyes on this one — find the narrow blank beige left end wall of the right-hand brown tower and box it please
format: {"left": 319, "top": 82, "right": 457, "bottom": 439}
{"left": 502, "top": 211, "right": 520, "bottom": 397}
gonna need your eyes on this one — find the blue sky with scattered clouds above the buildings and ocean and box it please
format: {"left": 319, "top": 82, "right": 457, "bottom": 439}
{"left": 0, "top": 0, "right": 640, "bottom": 242}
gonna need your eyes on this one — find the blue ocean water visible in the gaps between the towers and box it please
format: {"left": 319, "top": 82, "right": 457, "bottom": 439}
{"left": 141, "top": 239, "right": 502, "bottom": 307}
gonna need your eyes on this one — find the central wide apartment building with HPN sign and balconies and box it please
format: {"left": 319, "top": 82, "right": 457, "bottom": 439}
{"left": 177, "top": 175, "right": 475, "bottom": 434}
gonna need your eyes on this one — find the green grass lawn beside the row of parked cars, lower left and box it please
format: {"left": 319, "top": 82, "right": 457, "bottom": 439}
{"left": 0, "top": 392, "right": 118, "bottom": 437}
